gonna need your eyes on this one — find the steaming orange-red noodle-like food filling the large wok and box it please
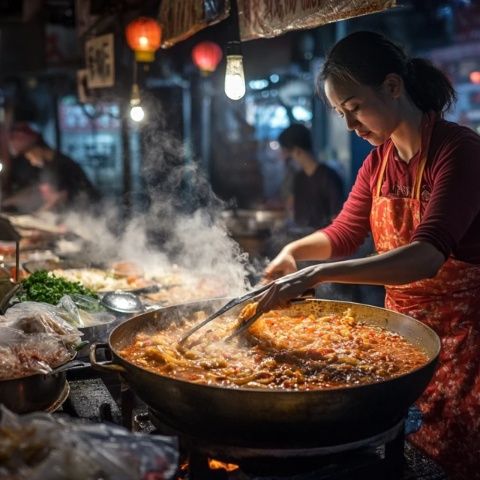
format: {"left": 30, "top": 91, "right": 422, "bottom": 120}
{"left": 120, "top": 306, "right": 428, "bottom": 390}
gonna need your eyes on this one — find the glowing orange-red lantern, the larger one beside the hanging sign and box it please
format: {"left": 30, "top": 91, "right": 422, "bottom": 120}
{"left": 125, "top": 17, "right": 162, "bottom": 62}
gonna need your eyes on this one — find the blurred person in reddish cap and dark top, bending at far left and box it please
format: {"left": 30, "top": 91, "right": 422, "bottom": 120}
{"left": 2, "top": 123, "right": 99, "bottom": 211}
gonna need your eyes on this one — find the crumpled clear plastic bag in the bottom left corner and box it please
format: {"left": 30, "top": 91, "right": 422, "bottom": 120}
{"left": 0, "top": 407, "right": 178, "bottom": 480}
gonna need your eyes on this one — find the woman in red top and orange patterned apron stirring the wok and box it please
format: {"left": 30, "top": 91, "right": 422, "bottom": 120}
{"left": 259, "top": 32, "right": 480, "bottom": 479}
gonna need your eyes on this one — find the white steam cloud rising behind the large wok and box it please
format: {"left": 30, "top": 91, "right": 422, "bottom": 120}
{"left": 64, "top": 95, "right": 252, "bottom": 294}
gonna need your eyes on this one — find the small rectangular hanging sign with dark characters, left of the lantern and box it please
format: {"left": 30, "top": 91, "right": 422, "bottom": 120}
{"left": 85, "top": 33, "right": 115, "bottom": 88}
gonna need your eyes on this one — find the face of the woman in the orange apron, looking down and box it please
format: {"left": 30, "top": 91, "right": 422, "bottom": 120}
{"left": 325, "top": 75, "right": 399, "bottom": 146}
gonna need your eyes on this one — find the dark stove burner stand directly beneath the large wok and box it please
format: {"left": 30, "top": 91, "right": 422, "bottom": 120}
{"left": 149, "top": 409, "right": 405, "bottom": 480}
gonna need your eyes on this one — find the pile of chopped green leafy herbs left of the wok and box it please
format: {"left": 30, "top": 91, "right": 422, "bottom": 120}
{"left": 18, "top": 270, "right": 98, "bottom": 305}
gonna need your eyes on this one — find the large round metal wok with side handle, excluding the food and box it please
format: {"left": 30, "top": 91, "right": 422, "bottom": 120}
{"left": 90, "top": 299, "right": 440, "bottom": 449}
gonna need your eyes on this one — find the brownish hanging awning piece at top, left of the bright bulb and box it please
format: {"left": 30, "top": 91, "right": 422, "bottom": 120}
{"left": 158, "top": 0, "right": 230, "bottom": 48}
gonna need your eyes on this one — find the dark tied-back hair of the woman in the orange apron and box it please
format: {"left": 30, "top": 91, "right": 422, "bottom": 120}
{"left": 317, "top": 32, "right": 456, "bottom": 113}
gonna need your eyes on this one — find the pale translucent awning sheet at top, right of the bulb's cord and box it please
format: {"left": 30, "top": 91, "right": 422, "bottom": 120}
{"left": 237, "top": 0, "right": 396, "bottom": 40}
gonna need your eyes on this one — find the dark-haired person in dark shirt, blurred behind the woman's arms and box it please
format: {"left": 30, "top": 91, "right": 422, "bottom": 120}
{"left": 278, "top": 123, "right": 344, "bottom": 230}
